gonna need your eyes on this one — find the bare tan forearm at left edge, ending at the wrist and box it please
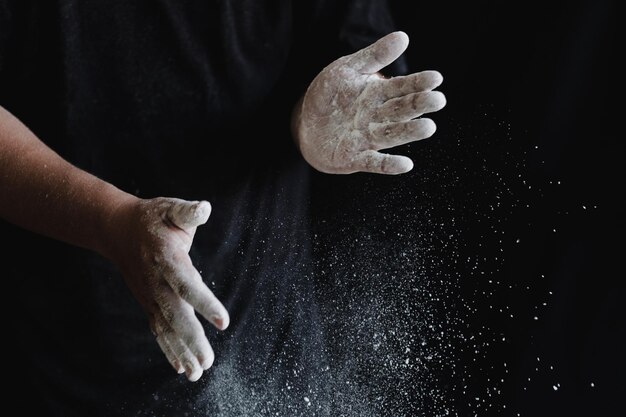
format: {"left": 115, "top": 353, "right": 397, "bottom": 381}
{"left": 0, "top": 107, "right": 136, "bottom": 254}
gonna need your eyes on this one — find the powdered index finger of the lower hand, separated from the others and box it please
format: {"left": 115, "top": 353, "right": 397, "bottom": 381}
{"left": 165, "top": 257, "right": 230, "bottom": 330}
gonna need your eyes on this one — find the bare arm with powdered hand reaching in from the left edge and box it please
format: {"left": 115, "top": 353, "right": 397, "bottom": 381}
{"left": 0, "top": 107, "right": 229, "bottom": 381}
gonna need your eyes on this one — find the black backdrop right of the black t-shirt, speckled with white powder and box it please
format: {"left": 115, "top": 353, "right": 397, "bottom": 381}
{"left": 7, "top": 0, "right": 626, "bottom": 417}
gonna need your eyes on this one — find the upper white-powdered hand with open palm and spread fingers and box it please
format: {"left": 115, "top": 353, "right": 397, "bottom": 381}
{"left": 294, "top": 32, "right": 446, "bottom": 174}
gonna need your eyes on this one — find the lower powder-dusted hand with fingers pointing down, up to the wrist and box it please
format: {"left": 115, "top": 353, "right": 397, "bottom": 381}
{"left": 105, "top": 198, "right": 229, "bottom": 381}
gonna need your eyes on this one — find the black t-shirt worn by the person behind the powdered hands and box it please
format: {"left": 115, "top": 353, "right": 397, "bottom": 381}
{"left": 0, "top": 0, "right": 402, "bottom": 417}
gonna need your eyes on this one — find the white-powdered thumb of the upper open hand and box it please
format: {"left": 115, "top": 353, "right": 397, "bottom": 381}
{"left": 347, "top": 32, "right": 409, "bottom": 74}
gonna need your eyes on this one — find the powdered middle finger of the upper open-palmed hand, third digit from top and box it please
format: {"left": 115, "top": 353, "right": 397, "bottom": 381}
{"left": 373, "top": 91, "right": 446, "bottom": 122}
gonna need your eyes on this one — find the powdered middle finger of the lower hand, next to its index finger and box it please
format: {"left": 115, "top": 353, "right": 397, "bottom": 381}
{"left": 158, "top": 290, "right": 215, "bottom": 369}
